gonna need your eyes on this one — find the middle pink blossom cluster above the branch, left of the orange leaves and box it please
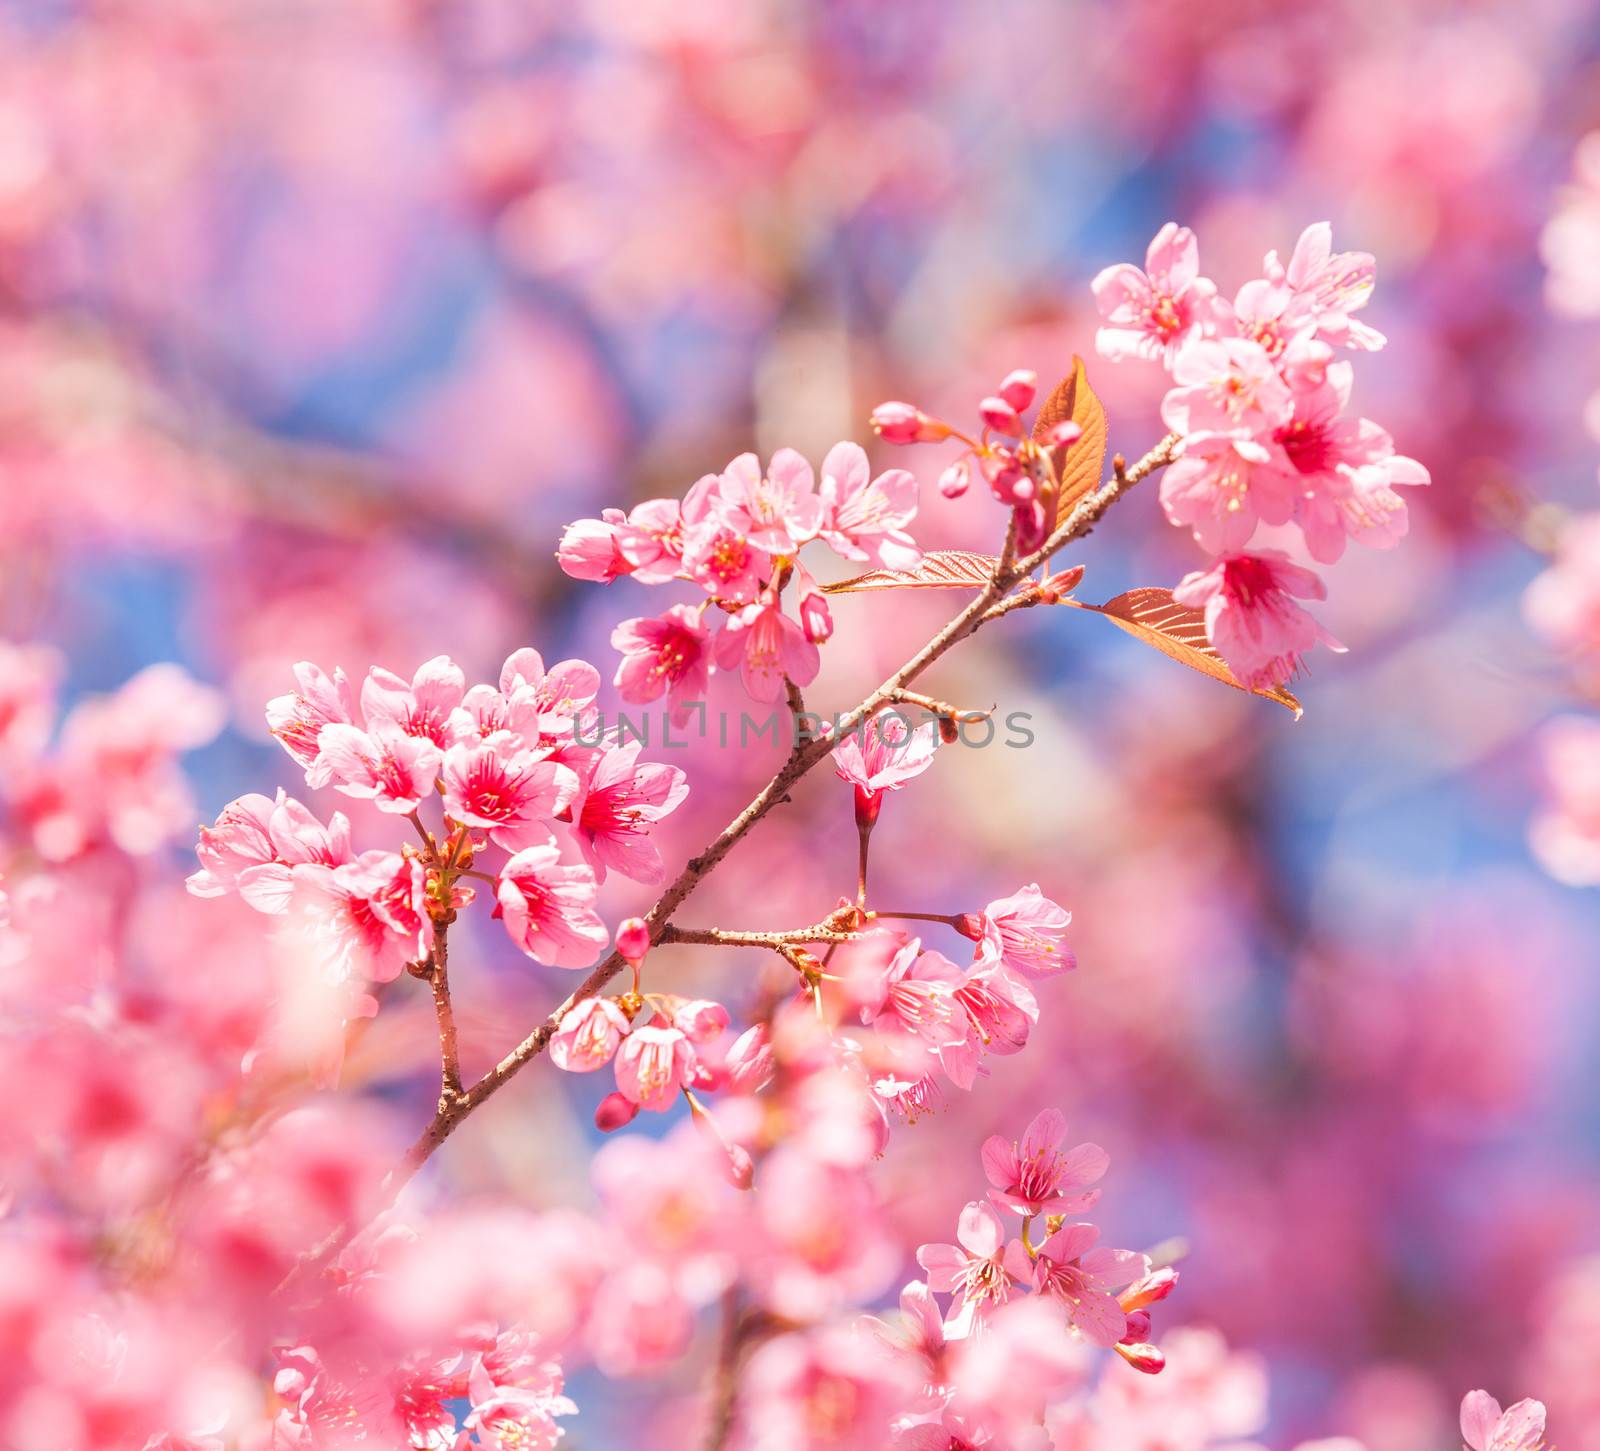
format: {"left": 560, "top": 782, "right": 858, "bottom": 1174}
{"left": 557, "top": 443, "right": 922, "bottom": 713}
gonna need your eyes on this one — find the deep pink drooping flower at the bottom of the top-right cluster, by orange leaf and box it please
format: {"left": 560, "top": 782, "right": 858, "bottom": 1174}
{"left": 1173, "top": 550, "right": 1344, "bottom": 690}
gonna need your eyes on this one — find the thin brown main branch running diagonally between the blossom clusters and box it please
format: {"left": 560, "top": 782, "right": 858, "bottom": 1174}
{"left": 386, "top": 434, "right": 1179, "bottom": 1195}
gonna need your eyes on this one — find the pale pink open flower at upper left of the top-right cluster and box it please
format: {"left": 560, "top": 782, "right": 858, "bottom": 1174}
{"left": 1091, "top": 222, "right": 1216, "bottom": 366}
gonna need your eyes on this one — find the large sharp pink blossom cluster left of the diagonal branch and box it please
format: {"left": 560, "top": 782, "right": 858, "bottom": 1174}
{"left": 189, "top": 650, "right": 688, "bottom": 1004}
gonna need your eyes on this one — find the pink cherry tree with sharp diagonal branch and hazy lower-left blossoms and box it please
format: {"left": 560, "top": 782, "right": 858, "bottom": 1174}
{"left": 0, "top": 215, "right": 1544, "bottom": 1451}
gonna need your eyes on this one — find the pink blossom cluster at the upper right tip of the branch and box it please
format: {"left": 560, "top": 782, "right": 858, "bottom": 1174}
{"left": 1094, "top": 222, "right": 1429, "bottom": 686}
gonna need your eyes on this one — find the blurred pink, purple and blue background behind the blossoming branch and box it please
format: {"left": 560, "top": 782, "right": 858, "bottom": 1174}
{"left": 9, "top": 0, "right": 1600, "bottom": 1451}
